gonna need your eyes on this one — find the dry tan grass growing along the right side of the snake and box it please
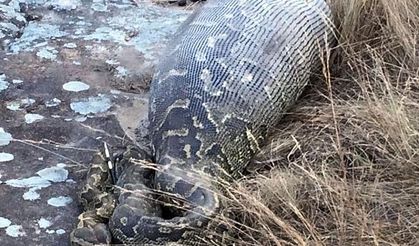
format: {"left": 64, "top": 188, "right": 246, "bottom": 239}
{"left": 215, "top": 0, "right": 419, "bottom": 245}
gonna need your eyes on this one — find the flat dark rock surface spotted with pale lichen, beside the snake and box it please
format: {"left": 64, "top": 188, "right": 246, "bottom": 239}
{"left": 0, "top": 0, "right": 194, "bottom": 245}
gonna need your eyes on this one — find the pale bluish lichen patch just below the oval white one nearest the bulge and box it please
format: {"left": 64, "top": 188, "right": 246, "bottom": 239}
{"left": 70, "top": 95, "right": 112, "bottom": 115}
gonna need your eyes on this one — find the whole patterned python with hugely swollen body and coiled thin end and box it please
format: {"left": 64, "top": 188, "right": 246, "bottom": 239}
{"left": 71, "top": 0, "right": 332, "bottom": 245}
